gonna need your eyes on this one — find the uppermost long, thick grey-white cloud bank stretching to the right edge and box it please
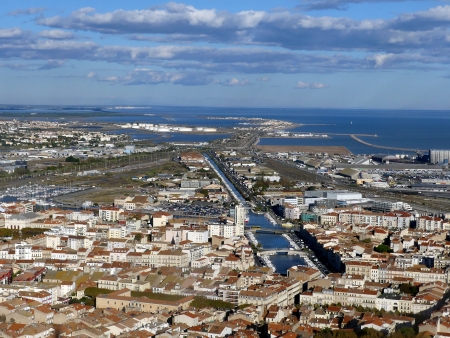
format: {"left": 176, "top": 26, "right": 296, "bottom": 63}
{"left": 32, "top": 0, "right": 450, "bottom": 53}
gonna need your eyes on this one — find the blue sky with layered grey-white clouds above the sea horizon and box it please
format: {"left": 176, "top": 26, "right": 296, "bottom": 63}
{"left": 0, "top": 0, "right": 450, "bottom": 110}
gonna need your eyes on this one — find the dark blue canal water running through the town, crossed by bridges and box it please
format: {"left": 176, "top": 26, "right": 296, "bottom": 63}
{"left": 204, "top": 154, "right": 306, "bottom": 274}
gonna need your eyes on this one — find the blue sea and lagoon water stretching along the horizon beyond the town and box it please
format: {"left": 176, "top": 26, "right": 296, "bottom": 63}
{"left": 0, "top": 106, "right": 450, "bottom": 154}
